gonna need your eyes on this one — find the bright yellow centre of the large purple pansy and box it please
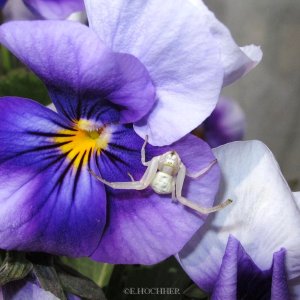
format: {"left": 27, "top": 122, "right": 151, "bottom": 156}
{"left": 54, "top": 119, "right": 111, "bottom": 168}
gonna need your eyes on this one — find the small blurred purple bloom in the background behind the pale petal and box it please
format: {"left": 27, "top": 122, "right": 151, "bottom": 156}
{"left": 203, "top": 97, "right": 246, "bottom": 147}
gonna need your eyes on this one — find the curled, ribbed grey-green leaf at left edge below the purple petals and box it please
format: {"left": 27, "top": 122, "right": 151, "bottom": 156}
{"left": 0, "top": 252, "right": 32, "bottom": 286}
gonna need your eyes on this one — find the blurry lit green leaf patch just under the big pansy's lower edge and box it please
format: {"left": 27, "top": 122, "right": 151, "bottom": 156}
{"left": 60, "top": 257, "right": 114, "bottom": 287}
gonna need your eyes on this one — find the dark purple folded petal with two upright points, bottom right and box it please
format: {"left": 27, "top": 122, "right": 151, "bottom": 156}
{"left": 210, "top": 236, "right": 289, "bottom": 300}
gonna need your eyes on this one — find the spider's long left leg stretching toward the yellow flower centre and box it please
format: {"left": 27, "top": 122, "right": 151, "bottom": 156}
{"left": 89, "top": 157, "right": 159, "bottom": 190}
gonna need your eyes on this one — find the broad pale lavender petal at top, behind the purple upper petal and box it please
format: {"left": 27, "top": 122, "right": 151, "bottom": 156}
{"left": 85, "top": 0, "right": 223, "bottom": 145}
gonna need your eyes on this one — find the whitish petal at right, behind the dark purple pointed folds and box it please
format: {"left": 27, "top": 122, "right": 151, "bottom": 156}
{"left": 179, "top": 141, "right": 300, "bottom": 290}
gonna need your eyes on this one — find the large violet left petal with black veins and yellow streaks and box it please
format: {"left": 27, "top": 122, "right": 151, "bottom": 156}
{"left": 0, "top": 97, "right": 106, "bottom": 256}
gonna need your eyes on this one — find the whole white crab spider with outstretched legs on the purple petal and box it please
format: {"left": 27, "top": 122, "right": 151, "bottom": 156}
{"left": 89, "top": 136, "right": 232, "bottom": 214}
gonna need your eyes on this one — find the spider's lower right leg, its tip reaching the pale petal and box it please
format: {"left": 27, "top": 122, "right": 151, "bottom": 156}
{"left": 176, "top": 164, "right": 232, "bottom": 215}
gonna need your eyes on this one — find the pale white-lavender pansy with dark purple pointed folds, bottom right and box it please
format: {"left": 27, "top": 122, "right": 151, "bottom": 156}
{"left": 178, "top": 141, "right": 300, "bottom": 300}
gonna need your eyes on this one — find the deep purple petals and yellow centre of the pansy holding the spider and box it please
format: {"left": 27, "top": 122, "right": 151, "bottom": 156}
{"left": 0, "top": 21, "right": 219, "bottom": 264}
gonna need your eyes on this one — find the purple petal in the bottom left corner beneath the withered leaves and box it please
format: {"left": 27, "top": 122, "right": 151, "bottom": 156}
{"left": 0, "top": 279, "right": 59, "bottom": 300}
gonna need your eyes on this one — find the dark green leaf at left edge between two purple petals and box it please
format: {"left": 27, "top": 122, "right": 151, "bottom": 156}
{"left": 0, "top": 68, "right": 51, "bottom": 105}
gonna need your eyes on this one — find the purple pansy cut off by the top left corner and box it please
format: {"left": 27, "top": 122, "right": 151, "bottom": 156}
{"left": 0, "top": 0, "right": 84, "bottom": 20}
